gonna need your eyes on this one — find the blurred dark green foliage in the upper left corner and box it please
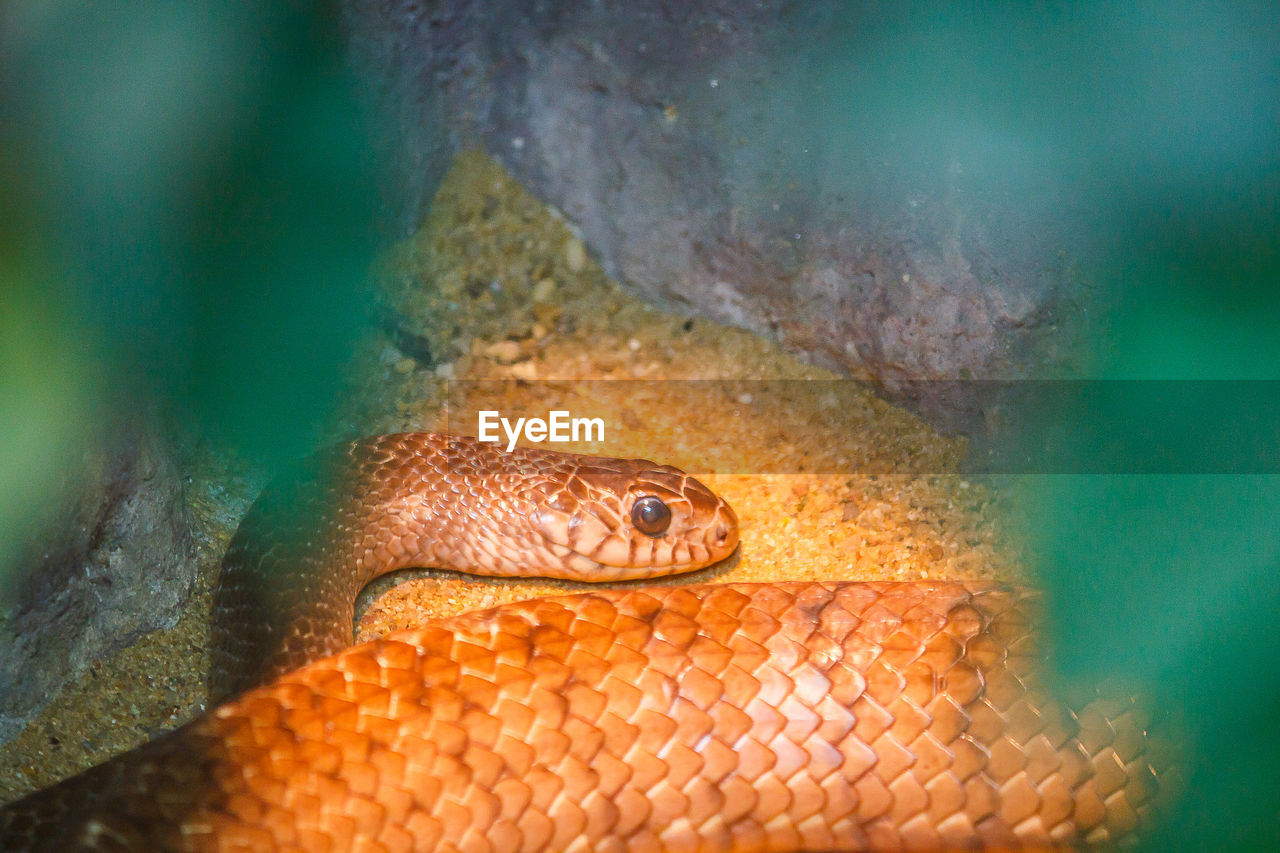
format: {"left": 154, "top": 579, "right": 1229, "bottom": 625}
{"left": 0, "top": 6, "right": 379, "bottom": 578}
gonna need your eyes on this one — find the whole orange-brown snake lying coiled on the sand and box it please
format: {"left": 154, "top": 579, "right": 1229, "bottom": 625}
{"left": 0, "top": 433, "right": 1162, "bottom": 853}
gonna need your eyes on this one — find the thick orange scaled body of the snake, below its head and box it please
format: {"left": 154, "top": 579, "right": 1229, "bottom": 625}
{"left": 0, "top": 439, "right": 1172, "bottom": 852}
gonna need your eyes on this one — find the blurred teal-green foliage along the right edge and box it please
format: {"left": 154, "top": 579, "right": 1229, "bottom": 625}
{"left": 778, "top": 0, "right": 1280, "bottom": 850}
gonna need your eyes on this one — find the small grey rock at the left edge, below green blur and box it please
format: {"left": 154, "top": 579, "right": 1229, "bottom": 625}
{"left": 0, "top": 428, "right": 196, "bottom": 742}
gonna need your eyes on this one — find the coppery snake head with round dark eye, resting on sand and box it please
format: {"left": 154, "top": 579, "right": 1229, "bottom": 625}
{"left": 536, "top": 457, "right": 737, "bottom": 580}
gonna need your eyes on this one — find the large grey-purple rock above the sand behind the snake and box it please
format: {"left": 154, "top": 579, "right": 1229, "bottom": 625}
{"left": 349, "top": 0, "right": 1080, "bottom": 428}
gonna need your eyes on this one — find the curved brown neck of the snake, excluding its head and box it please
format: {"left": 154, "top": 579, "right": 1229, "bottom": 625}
{"left": 209, "top": 433, "right": 483, "bottom": 702}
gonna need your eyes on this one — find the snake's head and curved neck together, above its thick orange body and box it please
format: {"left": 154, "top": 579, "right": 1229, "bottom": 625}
{"left": 210, "top": 433, "right": 737, "bottom": 699}
